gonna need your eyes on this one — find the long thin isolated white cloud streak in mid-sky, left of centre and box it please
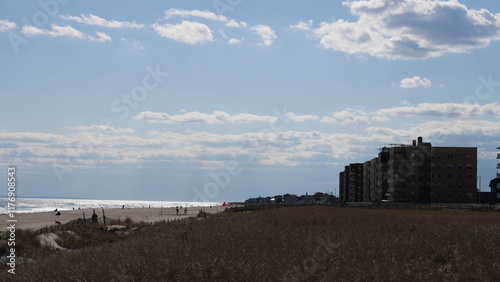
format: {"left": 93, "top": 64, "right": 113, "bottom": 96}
{"left": 132, "top": 111, "right": 278, "bottom": 124}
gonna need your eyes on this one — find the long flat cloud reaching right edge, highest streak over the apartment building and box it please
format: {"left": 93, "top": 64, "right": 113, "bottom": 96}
{"left": 377, "top": 103, "right": 500, "bottom": 118}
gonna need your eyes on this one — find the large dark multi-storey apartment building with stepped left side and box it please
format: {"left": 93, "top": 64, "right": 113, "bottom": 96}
{"left": 339, "top": 137, "right": 477, "bottom": 203}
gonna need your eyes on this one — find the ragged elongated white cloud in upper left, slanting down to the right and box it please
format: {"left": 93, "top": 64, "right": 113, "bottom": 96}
{"left": 21, "top": 24, "right": 111, "bottom": 42}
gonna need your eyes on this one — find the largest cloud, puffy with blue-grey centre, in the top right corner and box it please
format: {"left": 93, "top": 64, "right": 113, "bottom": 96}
{"left": 314, "top": 0, "right": 500, "bottom": 60}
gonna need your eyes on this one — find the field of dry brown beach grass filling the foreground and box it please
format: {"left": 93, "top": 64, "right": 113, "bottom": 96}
{"left": 0, "top": 206, "right": 500, "bottom": 281}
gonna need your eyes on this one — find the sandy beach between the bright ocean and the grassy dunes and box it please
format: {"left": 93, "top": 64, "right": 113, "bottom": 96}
{"left": 0, "top": 206, "right": 225, "bottom": 231}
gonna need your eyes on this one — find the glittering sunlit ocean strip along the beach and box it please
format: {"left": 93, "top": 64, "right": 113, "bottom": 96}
{"left": 0, "top": 197, "right": 221, "bottom": 214}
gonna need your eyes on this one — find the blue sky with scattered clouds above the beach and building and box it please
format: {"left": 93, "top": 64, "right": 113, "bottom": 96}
{"left": 0, "top": 0, "right": 500, "bottom": 201}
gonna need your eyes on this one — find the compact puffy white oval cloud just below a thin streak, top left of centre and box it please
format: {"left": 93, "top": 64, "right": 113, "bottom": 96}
{"left": 152, "top": 21, "right": 213, "bottom": 44}
